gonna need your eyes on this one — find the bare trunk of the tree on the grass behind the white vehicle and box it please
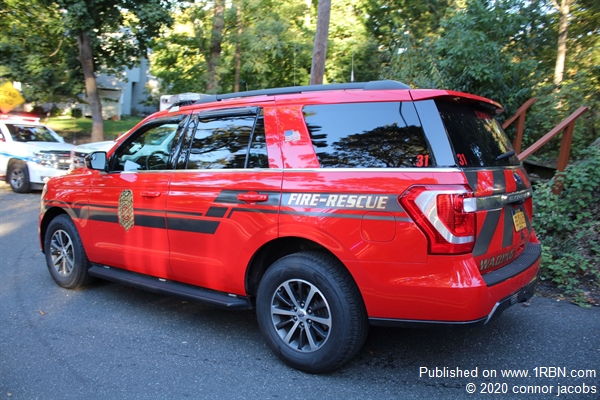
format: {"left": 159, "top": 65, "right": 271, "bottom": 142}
{"left": 77, "top": 32, "right": 104, "bottom": 142}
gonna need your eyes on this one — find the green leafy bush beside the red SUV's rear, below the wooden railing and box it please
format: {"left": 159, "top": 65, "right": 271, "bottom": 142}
{"left": 534, "top": 142, "right": 600, "bottom": 304}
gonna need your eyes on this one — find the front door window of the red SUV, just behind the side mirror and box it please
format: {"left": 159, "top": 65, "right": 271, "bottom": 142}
{"left": 111, "top": 120, "right": 181, "bottom": 171}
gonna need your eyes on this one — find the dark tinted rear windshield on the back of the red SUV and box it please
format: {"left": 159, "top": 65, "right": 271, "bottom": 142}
{"left": 436, "top": 100, "right": 519, "bottom": 168}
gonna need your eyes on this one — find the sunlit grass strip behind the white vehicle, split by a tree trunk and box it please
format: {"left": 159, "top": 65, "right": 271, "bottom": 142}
{"left": 46, "top": 116, "right": 142, "bottom": 144}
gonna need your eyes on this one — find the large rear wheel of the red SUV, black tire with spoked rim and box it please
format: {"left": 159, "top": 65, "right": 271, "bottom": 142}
{"left": 256, "top": 251, "right": 369, "bottom": 373}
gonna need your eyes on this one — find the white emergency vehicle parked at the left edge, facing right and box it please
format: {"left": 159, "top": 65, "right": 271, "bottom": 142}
{"left": 0, "top": 115, "right": 74, "bottom": 193}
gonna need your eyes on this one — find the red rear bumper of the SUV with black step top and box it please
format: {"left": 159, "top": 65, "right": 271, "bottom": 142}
{"left": 349, "top": 241, "right": 541, "bottom": 326}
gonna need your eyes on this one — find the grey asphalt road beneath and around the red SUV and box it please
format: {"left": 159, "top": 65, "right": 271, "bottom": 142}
{"left": 0, "top": 184, "right": 600, "bottom": 400}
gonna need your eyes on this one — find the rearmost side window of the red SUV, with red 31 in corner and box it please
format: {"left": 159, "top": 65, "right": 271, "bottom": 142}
{"left": 303, "top": 102, "right": 435, "bottom": 168}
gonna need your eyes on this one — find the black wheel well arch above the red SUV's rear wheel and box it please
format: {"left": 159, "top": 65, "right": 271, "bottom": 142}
{"left": 246, "top": 237, "right": 335, "bottom": 297}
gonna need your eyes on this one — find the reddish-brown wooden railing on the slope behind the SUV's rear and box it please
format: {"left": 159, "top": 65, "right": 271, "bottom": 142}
{"left": 502, "top": 98, "right": 589, "bottom": 194}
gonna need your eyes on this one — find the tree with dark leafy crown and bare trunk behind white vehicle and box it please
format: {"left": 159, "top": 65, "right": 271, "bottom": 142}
{"left": 48, "top": 0, "right": 172, "bottom": 141}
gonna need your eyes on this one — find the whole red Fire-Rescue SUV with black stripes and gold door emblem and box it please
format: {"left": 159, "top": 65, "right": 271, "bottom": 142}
{"left": 39, "top": 81, "right": 541, "bottom": 373}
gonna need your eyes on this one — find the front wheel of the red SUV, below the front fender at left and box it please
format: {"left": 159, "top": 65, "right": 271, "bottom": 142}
{"left": 44, "top": 214, "right": 92, "bottom": 289}
